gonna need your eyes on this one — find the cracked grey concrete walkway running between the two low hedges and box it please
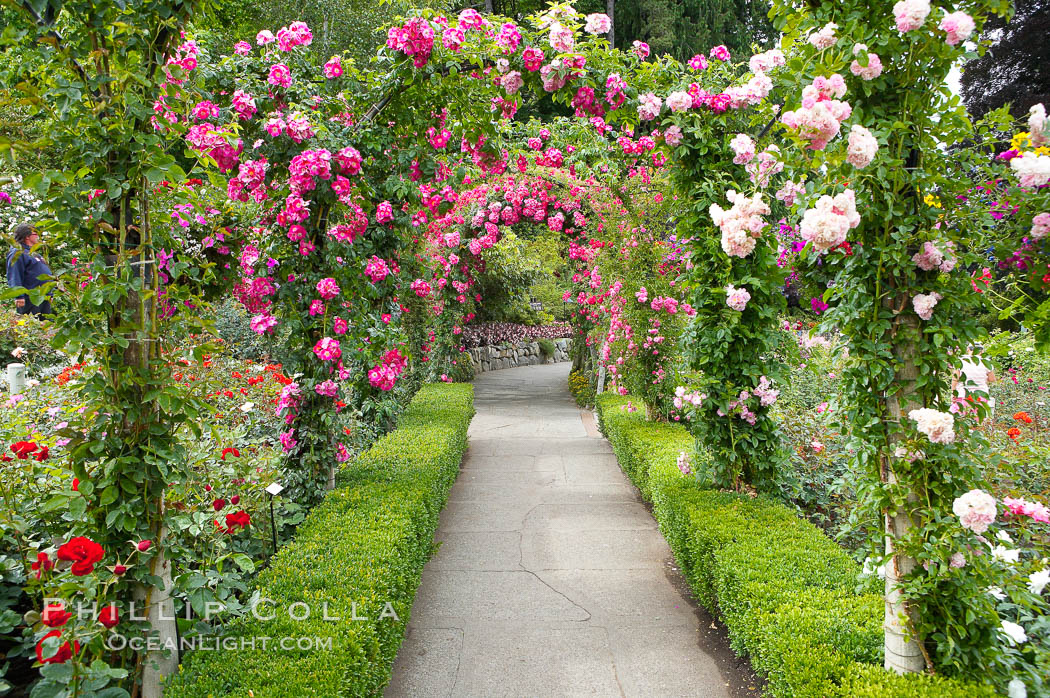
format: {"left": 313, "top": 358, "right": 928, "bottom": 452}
{"left": 385, "top": 363, "right": 736, "bottom": 698}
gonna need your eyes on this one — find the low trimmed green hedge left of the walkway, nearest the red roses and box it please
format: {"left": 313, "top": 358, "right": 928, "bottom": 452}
{"left": 165, "top": 384, "right": 474, "bottom": 698}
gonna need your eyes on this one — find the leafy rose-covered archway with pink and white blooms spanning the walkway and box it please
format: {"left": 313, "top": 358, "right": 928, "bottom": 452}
{"left": 2, "top": 0, "right": 1050, "bottom": 695}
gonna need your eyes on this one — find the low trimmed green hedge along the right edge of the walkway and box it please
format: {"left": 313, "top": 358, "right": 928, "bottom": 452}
{"left": 597, "top": 394, "right": 995, "bottom": 698}
